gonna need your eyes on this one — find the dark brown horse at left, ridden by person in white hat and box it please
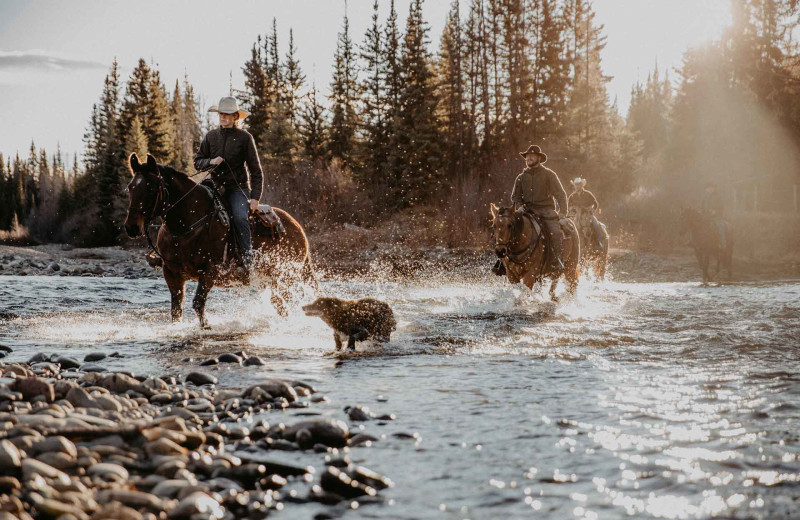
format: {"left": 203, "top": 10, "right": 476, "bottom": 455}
{"left": 125, "top": 154, "right": 315, "bottom": 327}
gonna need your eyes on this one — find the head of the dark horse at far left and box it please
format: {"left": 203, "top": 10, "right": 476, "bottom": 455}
{"left": 125, "top": 153, "right": 165, "bottom": 238}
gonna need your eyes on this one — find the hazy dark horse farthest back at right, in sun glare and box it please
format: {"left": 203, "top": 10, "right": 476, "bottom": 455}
{"left": 680, "top": 208, "right": 733, "bottom": 283}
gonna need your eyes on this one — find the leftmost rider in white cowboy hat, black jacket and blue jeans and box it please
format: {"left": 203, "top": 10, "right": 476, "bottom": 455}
{"left": 194, "top": 97, "right": 264, "bottom": 275}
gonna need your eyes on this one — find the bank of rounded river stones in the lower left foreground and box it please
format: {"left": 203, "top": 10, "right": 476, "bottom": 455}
{"left": 0, "top": 347, "right": 392, "bottom": 520}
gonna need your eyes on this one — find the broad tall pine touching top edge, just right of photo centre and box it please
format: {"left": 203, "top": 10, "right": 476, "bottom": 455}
{"left": 389, "top": 0, "right": 443, "bottom": 206}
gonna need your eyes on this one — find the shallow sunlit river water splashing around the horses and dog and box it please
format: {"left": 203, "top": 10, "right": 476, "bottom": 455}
{"left": 0, "top": 277, "right": 800, "bottom": 519}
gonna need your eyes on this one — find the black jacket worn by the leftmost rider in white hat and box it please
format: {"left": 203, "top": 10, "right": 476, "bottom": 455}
{"left": 194, "top": 128, "right": 264, "bottom": 200}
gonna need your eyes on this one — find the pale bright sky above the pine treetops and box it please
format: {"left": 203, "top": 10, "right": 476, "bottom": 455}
{"left": 0, "top": 0, "right": 730, "bottom": 162}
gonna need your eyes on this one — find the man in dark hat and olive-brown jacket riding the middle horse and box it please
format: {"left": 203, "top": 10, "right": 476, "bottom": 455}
{"left": 492, "top": 145, "right": 569, "bottom": 276}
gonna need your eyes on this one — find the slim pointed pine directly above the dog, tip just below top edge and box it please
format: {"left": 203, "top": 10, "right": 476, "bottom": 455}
{"left": 328, "top": 8, "right": 358, "bottom": 168}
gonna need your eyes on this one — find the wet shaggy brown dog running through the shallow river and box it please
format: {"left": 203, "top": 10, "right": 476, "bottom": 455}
{"left": 303, "top": 298, "right": 397, "bottom": 350}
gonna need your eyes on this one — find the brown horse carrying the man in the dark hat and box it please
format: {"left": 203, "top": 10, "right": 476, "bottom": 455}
{"left": 490, "top": 204, "right": 581, "bottom": 301}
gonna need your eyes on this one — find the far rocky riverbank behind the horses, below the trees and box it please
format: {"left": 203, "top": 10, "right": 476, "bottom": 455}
{"left": 0, "top": 242, "right": 800, "bottom": 282}
